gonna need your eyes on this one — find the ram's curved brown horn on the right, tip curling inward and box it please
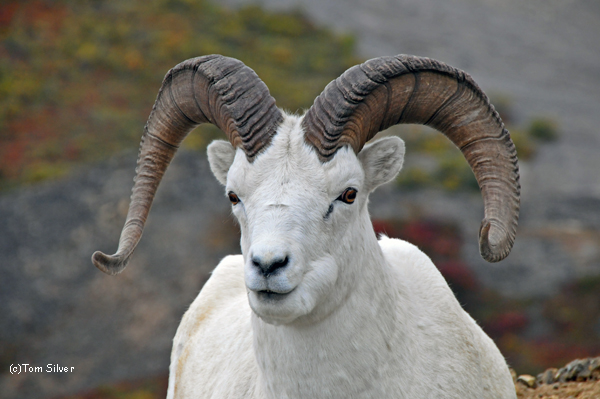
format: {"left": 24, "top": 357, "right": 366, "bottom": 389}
{"left": 302, "top": 55, "right": 521, "bottom": 262}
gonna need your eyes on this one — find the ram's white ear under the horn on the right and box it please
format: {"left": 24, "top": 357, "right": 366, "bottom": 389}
{"left": 358, "top": 136, "right": 404, "bottom": 191}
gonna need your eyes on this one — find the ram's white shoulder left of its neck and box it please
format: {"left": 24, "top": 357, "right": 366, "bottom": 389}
{"left": 169, "top": 255, "right": 258, "bottom": 397}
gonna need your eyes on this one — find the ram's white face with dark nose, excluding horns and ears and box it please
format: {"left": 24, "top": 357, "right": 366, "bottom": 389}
{"left": 209, "top": 117, "right": 403, "bottom": 324}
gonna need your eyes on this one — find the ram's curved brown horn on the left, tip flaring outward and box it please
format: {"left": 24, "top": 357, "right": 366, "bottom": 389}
{"left": 92, "top": 55, "right": 283, "bottom": 275}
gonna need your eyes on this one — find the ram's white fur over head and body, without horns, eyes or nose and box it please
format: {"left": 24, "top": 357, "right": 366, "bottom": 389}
{"left": 167, "top": 112, "right": 516, "bottom": 399}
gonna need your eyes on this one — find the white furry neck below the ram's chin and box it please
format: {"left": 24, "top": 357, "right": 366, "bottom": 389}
{"left": 248, "top": 211, "right": 402, "bottom": 398}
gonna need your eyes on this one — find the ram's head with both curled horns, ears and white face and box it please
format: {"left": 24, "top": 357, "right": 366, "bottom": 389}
{"left": 92, "top": 55, "right": 520, "bottom": 322}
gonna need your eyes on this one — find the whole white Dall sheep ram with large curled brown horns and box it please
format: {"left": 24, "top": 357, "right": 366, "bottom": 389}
{"left": 92, "top": 55, "right": 520, "bottom": 399}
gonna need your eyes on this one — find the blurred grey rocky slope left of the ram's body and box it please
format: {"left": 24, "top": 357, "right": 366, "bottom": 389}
{"left": 0, "top": 152, "right": 239, "bottom": 399}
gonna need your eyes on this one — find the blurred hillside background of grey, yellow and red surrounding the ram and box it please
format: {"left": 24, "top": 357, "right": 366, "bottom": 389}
{"left": 0, "top": 0, "right": 600, "bottom": 399}
